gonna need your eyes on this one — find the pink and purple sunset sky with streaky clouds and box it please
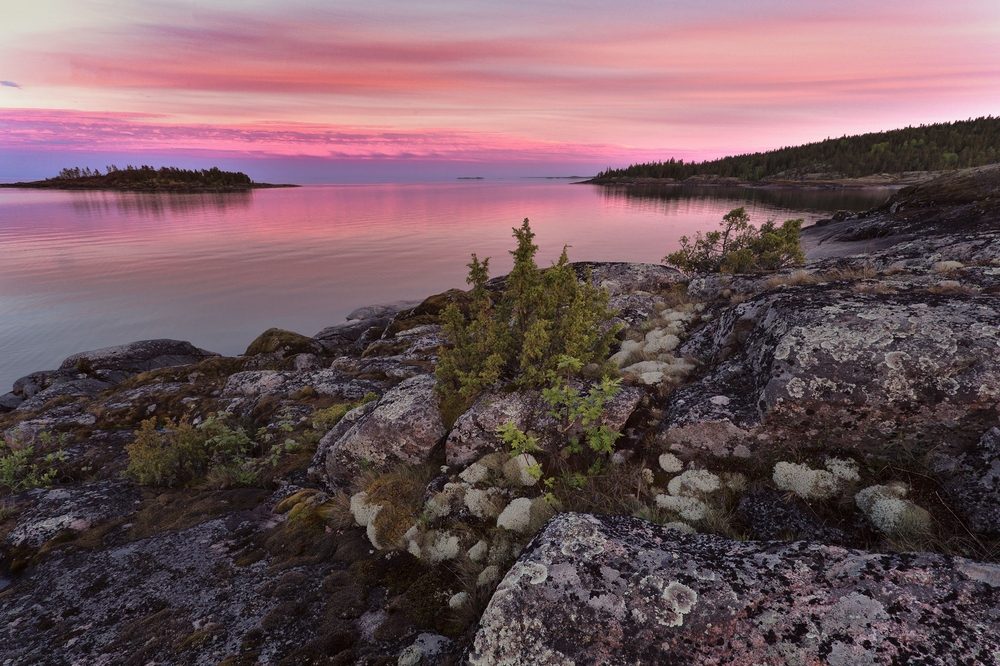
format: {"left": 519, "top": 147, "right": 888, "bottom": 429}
{"left": 0, "top": 0, "right": 1000, "bottom": 182}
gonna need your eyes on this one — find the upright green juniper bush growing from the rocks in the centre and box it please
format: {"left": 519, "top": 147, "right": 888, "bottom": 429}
{"left": 436, "top": 219, "right": 617, "bottom": 405}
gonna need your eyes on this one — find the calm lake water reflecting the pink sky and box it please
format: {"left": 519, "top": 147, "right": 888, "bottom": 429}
{"left": 0, "top": 180, "right": 890, "bottom": 393}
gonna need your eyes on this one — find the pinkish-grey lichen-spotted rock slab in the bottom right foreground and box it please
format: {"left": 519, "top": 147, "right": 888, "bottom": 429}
{"left": 469, "top": 514, "right": 1000, "bottom": 666}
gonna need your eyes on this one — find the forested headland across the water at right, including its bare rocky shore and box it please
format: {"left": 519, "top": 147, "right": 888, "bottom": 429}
{"left": 585, "top": 116, "right": 1000, "bottom": 189}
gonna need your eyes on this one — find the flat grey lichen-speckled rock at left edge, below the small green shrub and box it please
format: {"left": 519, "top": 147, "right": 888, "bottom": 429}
{"left": 6, "top": 481, "right": 142, "bottom": 548}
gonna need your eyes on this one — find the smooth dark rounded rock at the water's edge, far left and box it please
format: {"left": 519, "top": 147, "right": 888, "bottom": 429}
{"left": 59, "top": 339, "right": 219, "bottom": 375}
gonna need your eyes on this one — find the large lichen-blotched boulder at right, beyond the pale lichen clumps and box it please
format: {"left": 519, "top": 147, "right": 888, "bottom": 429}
{"left": 659, "top": 282, "right": 1000, "bottom": 455}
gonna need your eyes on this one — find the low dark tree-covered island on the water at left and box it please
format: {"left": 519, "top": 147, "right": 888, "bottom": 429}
{"left": 0, "top": 164, "right": 298, "bottom": 192}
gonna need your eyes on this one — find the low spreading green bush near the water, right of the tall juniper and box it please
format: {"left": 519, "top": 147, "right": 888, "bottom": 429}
{"left": 663, "top": 207, "right": 805, "bottom": 273}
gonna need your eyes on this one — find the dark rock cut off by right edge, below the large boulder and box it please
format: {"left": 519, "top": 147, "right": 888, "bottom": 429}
{"left": 944, "top": 427, "right": 1000, "bottom": 536}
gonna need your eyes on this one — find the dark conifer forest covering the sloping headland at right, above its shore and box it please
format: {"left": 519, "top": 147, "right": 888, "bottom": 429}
{"left": 597, "top": 116, "right": 1000, "bottom": 181}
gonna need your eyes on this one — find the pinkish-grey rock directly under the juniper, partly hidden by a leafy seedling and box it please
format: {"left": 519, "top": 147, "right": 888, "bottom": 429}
{"left": 445, "top": 386, "right": 644, "bottom": 465}
